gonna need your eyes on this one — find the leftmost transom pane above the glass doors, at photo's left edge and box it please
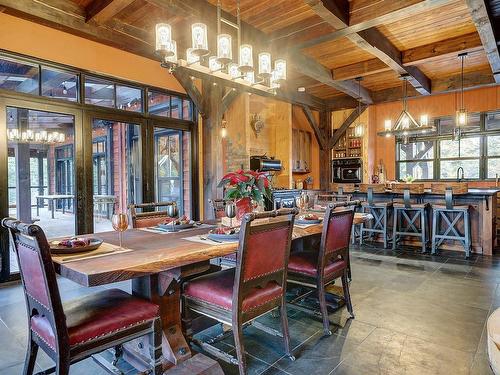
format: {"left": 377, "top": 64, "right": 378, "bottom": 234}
{"left": 0, "top": 57, "right": 39, "bottom": 95}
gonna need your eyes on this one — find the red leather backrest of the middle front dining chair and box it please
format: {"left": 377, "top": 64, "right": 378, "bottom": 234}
{"left": 233, "top": 208, "right": 299, "bottom": 319}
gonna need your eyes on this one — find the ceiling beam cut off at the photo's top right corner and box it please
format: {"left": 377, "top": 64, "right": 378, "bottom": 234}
{"left": 466, "top": 0, "right": 500, "bottom": 83}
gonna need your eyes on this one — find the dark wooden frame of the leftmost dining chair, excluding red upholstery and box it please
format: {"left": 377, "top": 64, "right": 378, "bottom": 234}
{"left": 2, "top": 218, "right": 162, "bottom": 375}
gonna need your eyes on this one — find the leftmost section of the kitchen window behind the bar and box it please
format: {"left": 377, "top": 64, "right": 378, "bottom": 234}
{"left": 398, "top": 141, "right": 434, "bottom": 180}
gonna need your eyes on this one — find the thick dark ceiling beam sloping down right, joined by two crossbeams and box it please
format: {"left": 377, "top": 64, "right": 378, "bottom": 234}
{"left": 306, "top": 0, "right": 431, "bottom": 95}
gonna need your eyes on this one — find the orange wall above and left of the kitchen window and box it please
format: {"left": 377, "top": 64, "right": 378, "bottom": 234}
{"left": 368, "top": 86, "right": 500, "bottom": 184}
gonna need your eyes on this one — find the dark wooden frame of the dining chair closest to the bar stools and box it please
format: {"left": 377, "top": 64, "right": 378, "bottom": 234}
{"left": 288, "top": 201, "right": 360, "bottom": 336}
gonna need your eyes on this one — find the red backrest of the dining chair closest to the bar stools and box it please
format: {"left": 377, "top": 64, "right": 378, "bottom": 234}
{"left": 317, "top": 206, "right": 354, "bottom": 278}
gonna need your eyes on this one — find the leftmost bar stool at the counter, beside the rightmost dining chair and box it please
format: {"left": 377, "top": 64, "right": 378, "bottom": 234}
{"left": 359, "top": 184, "right": 392, "bottom": 249}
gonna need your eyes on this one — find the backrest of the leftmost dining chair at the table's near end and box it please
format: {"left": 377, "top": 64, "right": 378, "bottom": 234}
{"left": 2, "top": 218, "right": 69, "bottom": 352}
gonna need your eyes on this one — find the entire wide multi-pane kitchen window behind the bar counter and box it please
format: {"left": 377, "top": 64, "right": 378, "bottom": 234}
{"left": 396, "top": 112, "right": 500, "bottom": 180}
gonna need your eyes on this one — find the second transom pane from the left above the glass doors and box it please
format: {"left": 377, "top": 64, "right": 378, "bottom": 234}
{"left": 41, "top": 67, "right": 79, "bottom": 102}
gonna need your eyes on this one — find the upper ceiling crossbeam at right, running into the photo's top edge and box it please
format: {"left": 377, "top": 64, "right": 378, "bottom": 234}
{"left": 295, "top": 0, "right": 451, "bottom": 50}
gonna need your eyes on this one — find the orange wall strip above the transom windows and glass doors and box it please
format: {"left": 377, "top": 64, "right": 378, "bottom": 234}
{"left": 0, "top": 13, "right": 184, "bottom": 92}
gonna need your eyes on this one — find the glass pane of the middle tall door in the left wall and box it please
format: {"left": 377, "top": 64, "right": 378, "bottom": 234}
{"left": 92, "top": 119, "right": 142, "bottom": 232}
